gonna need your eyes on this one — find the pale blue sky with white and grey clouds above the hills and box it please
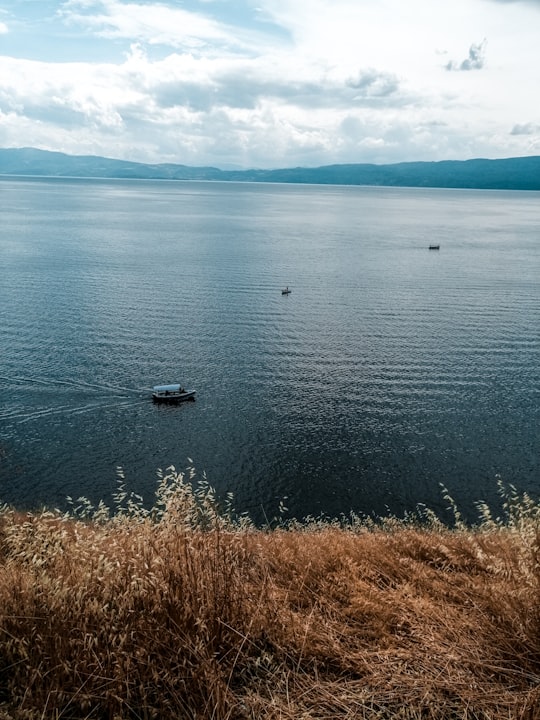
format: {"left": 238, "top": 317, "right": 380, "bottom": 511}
{"left": 0, "top": 0, "right": 540, "bottom": 168}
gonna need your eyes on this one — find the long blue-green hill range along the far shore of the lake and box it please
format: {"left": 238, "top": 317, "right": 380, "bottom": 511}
{"left": 0, "top": 148, "right": 540, "bottom": 190}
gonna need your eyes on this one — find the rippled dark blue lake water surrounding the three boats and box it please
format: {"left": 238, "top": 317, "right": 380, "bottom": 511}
{"left": 0, "top": 179, "right": 540, "bottom": 520}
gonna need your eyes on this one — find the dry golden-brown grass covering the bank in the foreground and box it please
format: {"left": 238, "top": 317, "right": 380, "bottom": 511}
{"left": 0, "top": 471, "right": 540, "bottom": 720}
